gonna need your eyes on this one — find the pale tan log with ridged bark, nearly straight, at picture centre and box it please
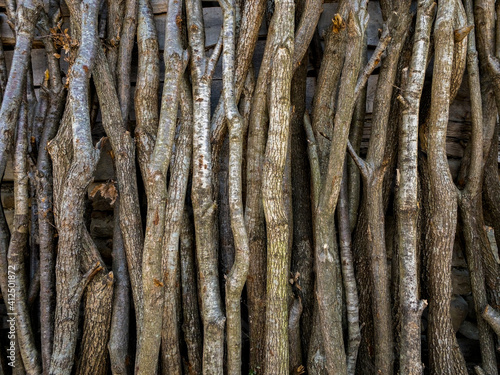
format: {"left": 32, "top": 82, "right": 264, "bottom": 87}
{"left": 262, "top": 0, "right": 294, "bottom": 375}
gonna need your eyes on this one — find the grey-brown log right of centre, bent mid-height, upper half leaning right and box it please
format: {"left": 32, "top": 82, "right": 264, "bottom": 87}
{"left": 313, "top": 10, "right": 364, "bottom": 374}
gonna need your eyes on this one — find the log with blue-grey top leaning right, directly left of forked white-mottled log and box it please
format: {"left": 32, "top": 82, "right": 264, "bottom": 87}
{"left": 135, "top": 1, "right": 187, "bottom": 374}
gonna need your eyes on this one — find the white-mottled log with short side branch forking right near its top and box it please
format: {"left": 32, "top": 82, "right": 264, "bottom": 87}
{"left": 186, "top": 0, "right": 226, "bottom": 375}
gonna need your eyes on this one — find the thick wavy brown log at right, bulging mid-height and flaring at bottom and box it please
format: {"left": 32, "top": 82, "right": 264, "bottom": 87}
{"left": 426, "top": 1, "right": 467, "bottom": 374}
